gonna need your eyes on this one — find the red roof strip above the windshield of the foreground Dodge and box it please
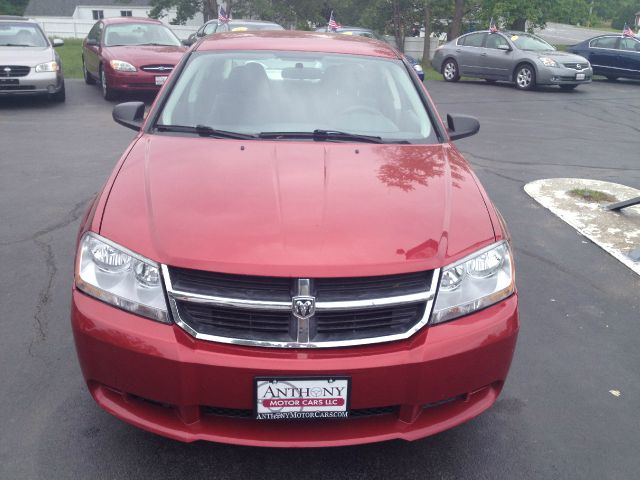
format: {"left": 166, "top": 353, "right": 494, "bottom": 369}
{"left": 196, "top": 30, "right": 399, "bottom": 58}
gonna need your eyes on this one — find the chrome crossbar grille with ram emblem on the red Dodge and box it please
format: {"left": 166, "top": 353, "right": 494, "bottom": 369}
{"left": 162, "top": 265, "right": 439, "bottom": 348}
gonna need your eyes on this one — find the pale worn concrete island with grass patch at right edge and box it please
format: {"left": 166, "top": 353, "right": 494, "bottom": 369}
{"left": 524, "top": 178, "right": 640, "bottom": 275}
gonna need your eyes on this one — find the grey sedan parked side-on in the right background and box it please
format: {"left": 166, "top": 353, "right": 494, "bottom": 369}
{"left": 431, "top": 30, "right": 593, "bottom": 90}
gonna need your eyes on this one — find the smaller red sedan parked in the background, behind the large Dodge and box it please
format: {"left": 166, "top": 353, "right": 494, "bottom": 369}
{"left": 82, "top": 17, "right": 187, "bottom": 100}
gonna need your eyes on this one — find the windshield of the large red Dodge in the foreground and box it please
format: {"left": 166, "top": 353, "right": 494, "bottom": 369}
{"left": 156, "top": 51, "right": 437, "bottom": 143}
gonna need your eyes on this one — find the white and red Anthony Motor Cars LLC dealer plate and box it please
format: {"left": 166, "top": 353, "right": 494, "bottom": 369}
{"left": 255, "top": 377, "right": 350, "bottom": 420}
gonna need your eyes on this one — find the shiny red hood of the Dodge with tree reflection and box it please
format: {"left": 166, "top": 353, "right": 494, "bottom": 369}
{"left": 100, "top": 135, "right": 495, "bottom": 277}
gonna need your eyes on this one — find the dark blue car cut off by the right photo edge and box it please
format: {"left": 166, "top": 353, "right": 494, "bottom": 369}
{"left": 568, "top": 34, "right": 640, "bottom": 80}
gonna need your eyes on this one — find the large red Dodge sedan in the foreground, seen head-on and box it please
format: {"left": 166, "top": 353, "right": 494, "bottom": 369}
{"left": 71, "top": 32, "right": 518, "bottom": 447}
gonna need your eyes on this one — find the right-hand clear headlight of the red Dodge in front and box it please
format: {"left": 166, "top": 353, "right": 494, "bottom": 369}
{"left": 431, "top": 242, "right": 515, "bottom": 324}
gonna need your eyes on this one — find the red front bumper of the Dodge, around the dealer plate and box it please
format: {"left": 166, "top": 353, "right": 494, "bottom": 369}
{"left": 71, "top": 290, "right": 518, "bottom": 447}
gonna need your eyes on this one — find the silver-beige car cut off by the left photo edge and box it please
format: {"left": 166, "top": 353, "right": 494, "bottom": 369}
{"left": 0, "top": 15, "right": 66, "bottom": 102}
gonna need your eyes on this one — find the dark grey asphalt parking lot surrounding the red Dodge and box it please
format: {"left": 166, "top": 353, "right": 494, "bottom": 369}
{"left": 0, "top": 80, "right": 640, "bottom": 480}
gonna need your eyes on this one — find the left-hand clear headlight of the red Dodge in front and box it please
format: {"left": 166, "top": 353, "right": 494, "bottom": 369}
{"left": 76, "top": 233, "right": 171, "bottom": 323}
